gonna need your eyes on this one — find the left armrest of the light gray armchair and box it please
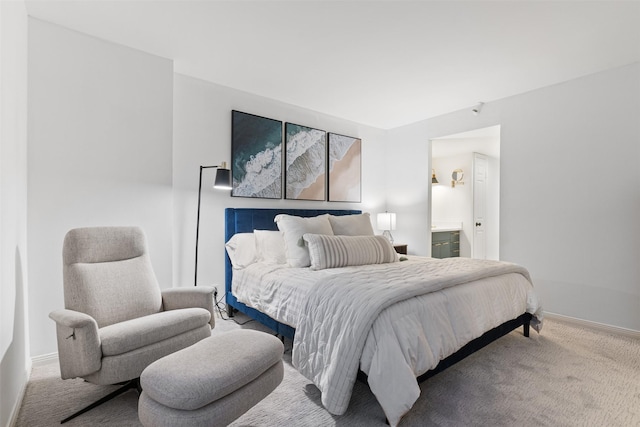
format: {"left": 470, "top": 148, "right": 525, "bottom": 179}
{"left": 49, "top": 309, "right": 102, "bottom": 379}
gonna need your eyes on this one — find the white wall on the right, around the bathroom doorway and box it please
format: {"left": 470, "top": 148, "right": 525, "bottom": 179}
{"left": 389, "top": 63, "right": 640, "bottom": 331}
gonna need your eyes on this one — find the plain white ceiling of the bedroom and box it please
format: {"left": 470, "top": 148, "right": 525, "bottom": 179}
{"left": 26, "top": 0, "right": 640, "bottom": 129}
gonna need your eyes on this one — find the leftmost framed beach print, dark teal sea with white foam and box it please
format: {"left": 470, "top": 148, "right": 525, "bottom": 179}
{"left": 231, "top": 110, "right": 282, "bottom": 199}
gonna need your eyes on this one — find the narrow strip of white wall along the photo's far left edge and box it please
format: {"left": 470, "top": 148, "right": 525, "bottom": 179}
{"left": 0, "top": 1, "right": 31, "bottom": 426}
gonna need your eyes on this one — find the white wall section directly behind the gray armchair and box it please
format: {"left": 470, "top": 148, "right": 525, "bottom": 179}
{"left": 28, "top": 19, "right": 173, "bottom": 355}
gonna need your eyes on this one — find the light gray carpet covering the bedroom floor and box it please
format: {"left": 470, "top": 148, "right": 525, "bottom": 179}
{"left": 17, "top": 318, "right": 640, "bottom": 427}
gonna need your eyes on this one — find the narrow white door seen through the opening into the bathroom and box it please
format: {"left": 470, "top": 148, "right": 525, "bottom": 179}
{"left": 471, "top": 153, "right": 489, "bottom": 259}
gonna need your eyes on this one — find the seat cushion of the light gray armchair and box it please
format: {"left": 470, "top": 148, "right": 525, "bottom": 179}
{"left": 99, "top": 308, "right": 211, "bottom": 356}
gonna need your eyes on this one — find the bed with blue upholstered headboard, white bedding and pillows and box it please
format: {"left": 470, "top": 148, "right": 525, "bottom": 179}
{"left": 225, "top": 208, "right": 542, "bottom": 426}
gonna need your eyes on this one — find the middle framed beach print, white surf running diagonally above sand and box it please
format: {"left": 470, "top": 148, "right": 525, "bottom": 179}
{"left": 284, "top": 123, "right": 327, "bottom": 200}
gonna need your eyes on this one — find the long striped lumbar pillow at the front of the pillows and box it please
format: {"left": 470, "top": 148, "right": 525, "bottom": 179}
{"left": 302, "top": 233, "right": 398, "bottom": 270}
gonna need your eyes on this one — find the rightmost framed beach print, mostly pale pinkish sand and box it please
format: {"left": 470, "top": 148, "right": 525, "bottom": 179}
{"left": 328, "top": 133, "right": 362, "bottom": 202}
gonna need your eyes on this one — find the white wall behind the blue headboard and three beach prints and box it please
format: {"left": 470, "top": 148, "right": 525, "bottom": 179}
{"left": 173, "top": 74, "right": 388, "bottom": 291}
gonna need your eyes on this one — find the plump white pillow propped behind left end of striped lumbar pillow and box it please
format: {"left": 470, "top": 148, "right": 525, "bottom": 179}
{"left": 274, "top": 214, "right": 333, "bottom": 267}
